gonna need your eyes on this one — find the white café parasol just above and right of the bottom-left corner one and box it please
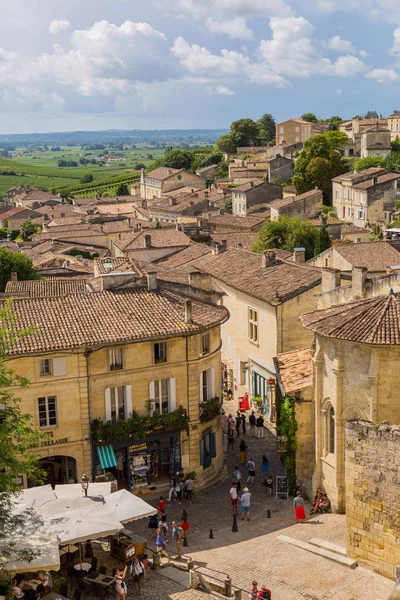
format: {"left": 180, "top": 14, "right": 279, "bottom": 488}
{"left": 45, "top": 504, "right": 122, "bottom": 544}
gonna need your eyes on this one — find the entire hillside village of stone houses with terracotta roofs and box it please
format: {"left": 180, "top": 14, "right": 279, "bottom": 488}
{"left": 0, "top": 111, "right": 400, "bottom": 597}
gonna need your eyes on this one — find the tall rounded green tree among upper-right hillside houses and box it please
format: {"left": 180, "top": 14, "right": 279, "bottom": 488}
{"left": 292, "top": 131, "right": 348, "bottom": 194}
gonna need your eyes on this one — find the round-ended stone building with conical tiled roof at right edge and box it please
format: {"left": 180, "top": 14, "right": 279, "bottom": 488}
{"left": 301, "top": 292, "right": 400, "bottom": 512}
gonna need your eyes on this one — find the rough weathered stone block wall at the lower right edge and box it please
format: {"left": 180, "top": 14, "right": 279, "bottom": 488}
{"left": 345, "top": 421, "right": 400, "bottom": 577}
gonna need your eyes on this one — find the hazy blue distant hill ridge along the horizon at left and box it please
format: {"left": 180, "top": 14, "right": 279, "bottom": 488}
{"left": 0, "top": 129, "right": 228, "bottom": 147}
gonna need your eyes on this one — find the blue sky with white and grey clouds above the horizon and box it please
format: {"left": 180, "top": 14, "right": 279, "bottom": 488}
{"left": 0, "top": 0, "right": 400, "bottom": 133}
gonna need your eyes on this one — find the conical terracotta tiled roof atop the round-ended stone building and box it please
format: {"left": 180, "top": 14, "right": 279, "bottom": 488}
{"left": 301, "top": 292, "right": 400, "bottom": 345}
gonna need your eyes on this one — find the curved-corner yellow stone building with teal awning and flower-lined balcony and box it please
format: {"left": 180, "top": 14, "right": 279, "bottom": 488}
{"left": 3, "top": 268, "right": 229, "bottom": 489}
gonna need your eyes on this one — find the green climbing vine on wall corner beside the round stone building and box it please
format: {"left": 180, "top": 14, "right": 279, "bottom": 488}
{"left": 277, "top": 389, "right": 298, "bottom": 495}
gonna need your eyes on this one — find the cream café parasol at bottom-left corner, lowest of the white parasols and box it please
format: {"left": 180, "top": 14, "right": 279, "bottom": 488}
{"left": 0, "top": 534, "right": 60, "bottom": 573}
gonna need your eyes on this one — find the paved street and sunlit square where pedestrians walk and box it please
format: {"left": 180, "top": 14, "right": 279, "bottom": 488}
{"left": 131, "top": 408, "right": 393, "bottom": 600}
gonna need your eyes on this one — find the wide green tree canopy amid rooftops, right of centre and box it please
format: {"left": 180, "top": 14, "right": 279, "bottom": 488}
{"left": 253, "top": 216, "right": 331, "bottom": 260}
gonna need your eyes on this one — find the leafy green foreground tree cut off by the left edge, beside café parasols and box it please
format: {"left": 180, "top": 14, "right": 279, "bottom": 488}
{"left": 0, "top": 300, "right": 47, "bottom": 572}
